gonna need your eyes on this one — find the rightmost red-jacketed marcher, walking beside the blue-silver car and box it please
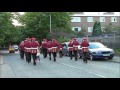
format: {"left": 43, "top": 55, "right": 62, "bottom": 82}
{"left": 81, "top": 38, "right": 89, "bottom": 63}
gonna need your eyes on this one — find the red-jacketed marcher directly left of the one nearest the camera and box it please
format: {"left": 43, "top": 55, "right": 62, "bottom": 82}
{"left": 24, "top": 38, "right": 31, "bottom": 63}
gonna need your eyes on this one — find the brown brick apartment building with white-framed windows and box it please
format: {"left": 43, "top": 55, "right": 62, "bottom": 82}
{"left": 70, "top": 12, "right": 120, "bottom": 36}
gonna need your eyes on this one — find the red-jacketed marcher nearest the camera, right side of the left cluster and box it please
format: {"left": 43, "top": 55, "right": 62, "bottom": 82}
{"left": 31, "top": 37, "right": 39, "bottom": 65}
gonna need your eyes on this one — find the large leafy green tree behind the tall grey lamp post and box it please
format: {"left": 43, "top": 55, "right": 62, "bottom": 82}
{"left": 17, "top": 12, "right": 71, "bottom": 40}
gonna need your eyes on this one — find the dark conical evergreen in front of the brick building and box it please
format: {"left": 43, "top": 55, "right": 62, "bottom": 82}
{"left": 92, "top": 21, "right": 102, "bottom": 35}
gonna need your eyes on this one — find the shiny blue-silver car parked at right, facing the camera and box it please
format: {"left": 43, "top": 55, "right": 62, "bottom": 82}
{"left": 79, "top": 42, "right": 114, "bottom": 60}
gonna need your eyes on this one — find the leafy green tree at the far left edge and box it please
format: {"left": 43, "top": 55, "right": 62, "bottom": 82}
{"left": 0, "top": 12, "right": 16, "bottom": 46}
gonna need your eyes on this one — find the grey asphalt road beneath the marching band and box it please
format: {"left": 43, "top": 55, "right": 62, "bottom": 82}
{"left": 0, "top": 51, "right": 120, "bottom": 78}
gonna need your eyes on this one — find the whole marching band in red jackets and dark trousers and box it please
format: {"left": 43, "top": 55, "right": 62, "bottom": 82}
{"left": 19, "top": 37, "right": 89, "bottom": 65}
